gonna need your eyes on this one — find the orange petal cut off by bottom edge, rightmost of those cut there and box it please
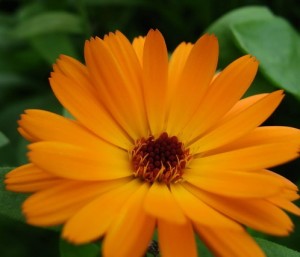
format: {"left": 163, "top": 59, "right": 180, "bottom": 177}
{"left": 195, "top": 224, "right": 266, "bottom": 257}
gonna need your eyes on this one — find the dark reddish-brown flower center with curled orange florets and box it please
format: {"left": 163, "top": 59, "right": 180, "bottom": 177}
{"left": 131, "top": 132, "right": 191, "bottom": 184}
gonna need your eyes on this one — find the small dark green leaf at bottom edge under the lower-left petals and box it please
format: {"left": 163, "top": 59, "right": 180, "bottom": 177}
{"left": 60, "top": 239, "right": 100, "bottom": 257}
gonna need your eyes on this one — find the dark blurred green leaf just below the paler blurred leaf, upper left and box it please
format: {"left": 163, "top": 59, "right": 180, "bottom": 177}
{"left": 30, "top": 33, "right": 78, "bottom": 65}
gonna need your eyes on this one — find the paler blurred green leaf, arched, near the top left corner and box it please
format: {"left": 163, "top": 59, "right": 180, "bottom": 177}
{"left": 12, "top": 11, "right": 83, "bottom": 39}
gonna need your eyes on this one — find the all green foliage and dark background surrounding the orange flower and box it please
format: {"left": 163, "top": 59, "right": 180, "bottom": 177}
{"left": 0, "top": 0, "right": 300, "bottom": 257}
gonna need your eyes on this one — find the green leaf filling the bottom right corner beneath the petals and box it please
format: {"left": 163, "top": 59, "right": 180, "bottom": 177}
{"left": 255, "top": 238, "right": 300, "bottom": 257}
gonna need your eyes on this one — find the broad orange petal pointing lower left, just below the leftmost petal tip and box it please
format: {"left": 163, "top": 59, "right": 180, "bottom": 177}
{"left": 22, "top": 180, "right": 124, "bottom": 226}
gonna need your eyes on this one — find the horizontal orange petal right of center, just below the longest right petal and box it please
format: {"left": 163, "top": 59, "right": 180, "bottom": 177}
{"left": 183, "top": 169, "right": 284, "bottom": 198}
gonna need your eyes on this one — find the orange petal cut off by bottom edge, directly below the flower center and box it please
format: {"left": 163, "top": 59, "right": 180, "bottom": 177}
{"left": 158, "top": 219, "right": 198, "bottom": 257}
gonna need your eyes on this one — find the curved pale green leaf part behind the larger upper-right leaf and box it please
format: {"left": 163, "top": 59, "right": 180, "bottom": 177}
{"left": 206, "top": 6, "right": 274, "bottom": 67}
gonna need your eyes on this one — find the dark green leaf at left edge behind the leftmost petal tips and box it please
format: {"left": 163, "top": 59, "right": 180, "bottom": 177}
{"left": 0, "top": 167, "right": 26, "bottom": 221}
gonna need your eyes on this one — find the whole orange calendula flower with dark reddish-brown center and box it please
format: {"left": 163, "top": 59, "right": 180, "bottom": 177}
{"left": 5, "top": 30, "right": 300, "bottom": 257}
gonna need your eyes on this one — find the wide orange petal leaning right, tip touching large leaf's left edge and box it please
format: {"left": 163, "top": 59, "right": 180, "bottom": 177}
{"left": 167, "top": 34, "right": 219, "bottom": 135}
